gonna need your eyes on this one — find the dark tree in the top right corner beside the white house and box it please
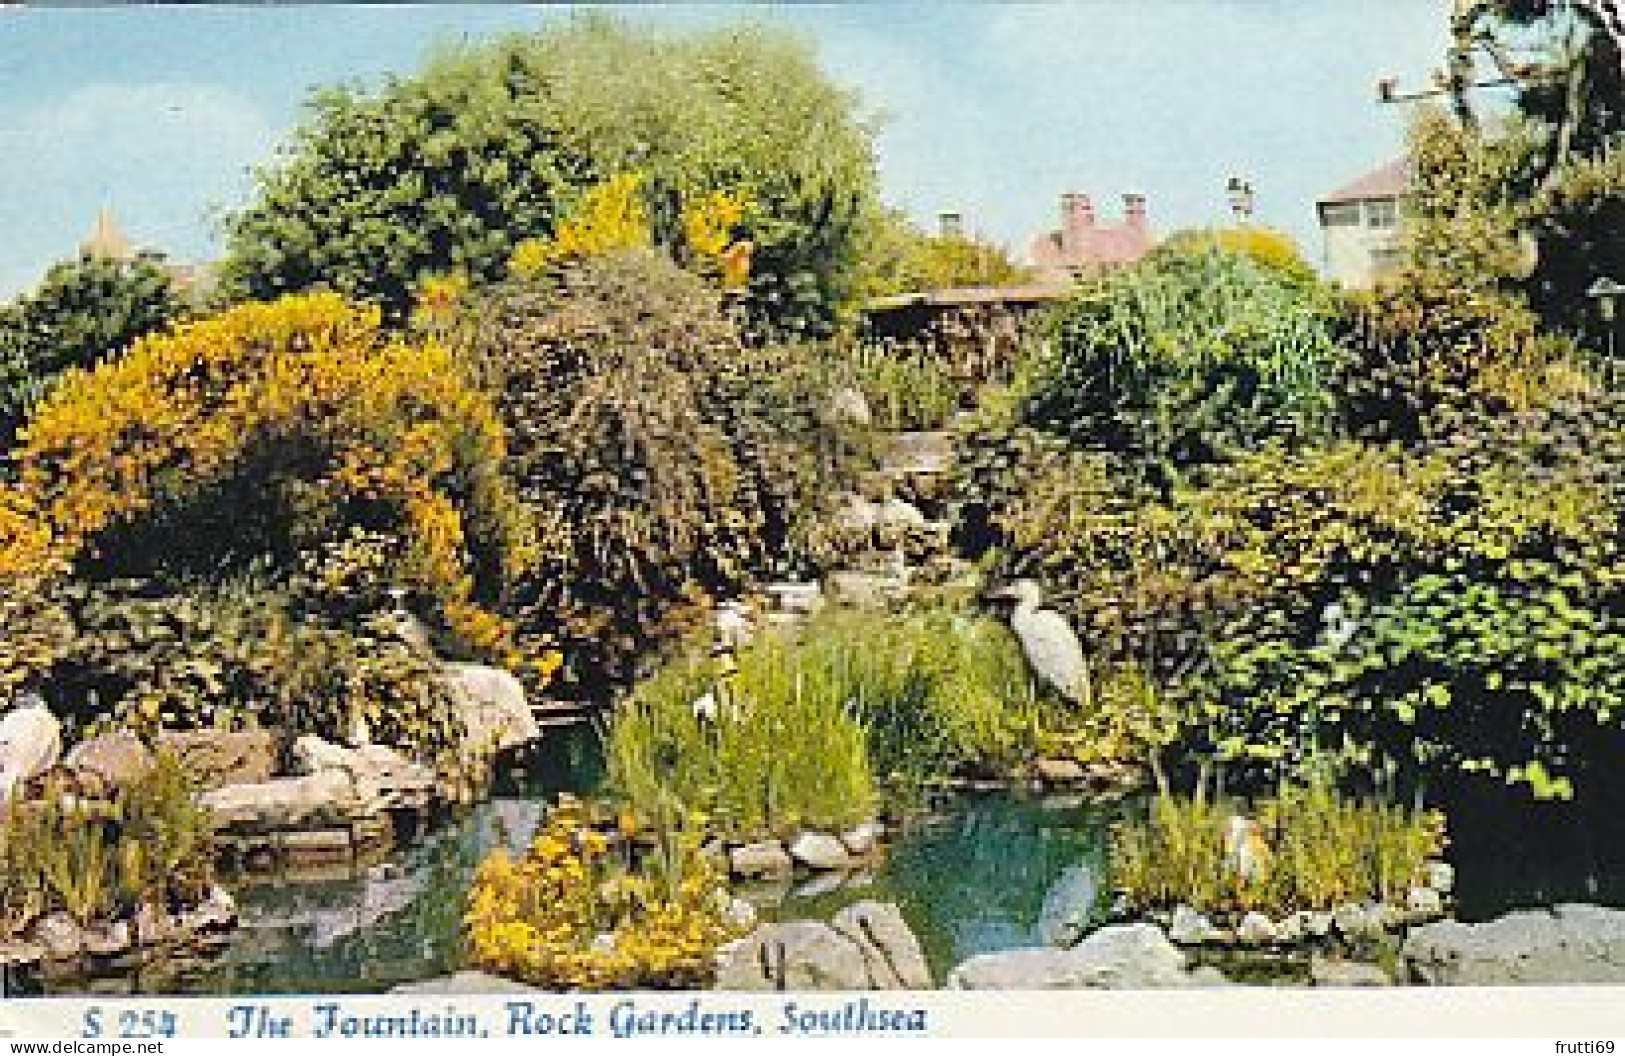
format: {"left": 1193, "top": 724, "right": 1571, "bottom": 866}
{"left": 1414, "top": 0, "right": 1625, "bottom": 338}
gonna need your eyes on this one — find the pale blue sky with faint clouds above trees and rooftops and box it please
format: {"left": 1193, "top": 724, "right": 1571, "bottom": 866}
{"left": 0, "top": 0, "right": 1448, "bottom": 297}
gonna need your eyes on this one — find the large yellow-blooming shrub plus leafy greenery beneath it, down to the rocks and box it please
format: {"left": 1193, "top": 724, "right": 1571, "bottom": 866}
{"left": 0, "top": 292, "right": 553, "bottom": 755}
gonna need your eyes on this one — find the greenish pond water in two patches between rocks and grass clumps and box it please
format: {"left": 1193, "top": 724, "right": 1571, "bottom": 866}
{"left": 76, "top": 727, "right": 1108, "bottom": 994}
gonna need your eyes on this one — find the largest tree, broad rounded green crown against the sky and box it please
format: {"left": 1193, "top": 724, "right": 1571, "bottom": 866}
{"left": 226, "top": 18, "right": 874, "bottom": 335}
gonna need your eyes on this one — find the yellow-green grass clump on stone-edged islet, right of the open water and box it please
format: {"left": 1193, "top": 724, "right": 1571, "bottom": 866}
{"left": 1112, "top": 780, "right": 1443, "bottom": 916}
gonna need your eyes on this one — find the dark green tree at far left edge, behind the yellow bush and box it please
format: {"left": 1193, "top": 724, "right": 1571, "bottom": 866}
{"left": 0, "top": 255, "right": 185, "bottom": 447}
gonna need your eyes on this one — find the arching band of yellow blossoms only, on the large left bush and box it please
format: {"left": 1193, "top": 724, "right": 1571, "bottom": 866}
{"left": 0, "top": 292, "right": 535, "bottom": 642}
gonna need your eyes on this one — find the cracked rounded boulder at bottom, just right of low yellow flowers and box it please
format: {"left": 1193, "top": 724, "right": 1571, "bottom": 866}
{"left": 717, "top": 921, "right": 869, "bottom": 991}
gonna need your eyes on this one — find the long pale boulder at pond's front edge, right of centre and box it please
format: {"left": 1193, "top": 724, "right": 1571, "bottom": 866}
{"left": 947, "top": 924, "right": 1224, "bottom": 989}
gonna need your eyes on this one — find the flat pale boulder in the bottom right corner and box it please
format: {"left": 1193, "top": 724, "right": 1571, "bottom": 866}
{"left": 1401, "top": 903, "right": 1625, "bottom": 986}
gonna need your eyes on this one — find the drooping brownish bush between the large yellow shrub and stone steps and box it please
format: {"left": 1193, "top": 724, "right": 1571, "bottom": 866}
{"left": 468, "top": 250, "right": 816, "bottom": 699}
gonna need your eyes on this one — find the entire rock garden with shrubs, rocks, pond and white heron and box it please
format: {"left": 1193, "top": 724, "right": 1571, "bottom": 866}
{"left": 0, "top": 8, "right": 1625, "bottom": 993}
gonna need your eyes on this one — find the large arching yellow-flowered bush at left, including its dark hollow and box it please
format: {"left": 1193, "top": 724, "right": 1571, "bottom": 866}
{"left": 0, "top": 292, "right": 533, "bottom": 651}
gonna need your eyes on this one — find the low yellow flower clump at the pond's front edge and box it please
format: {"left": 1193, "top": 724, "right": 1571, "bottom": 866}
{"left": 466, "top": 803, "right": 739, "bottom": 989}
